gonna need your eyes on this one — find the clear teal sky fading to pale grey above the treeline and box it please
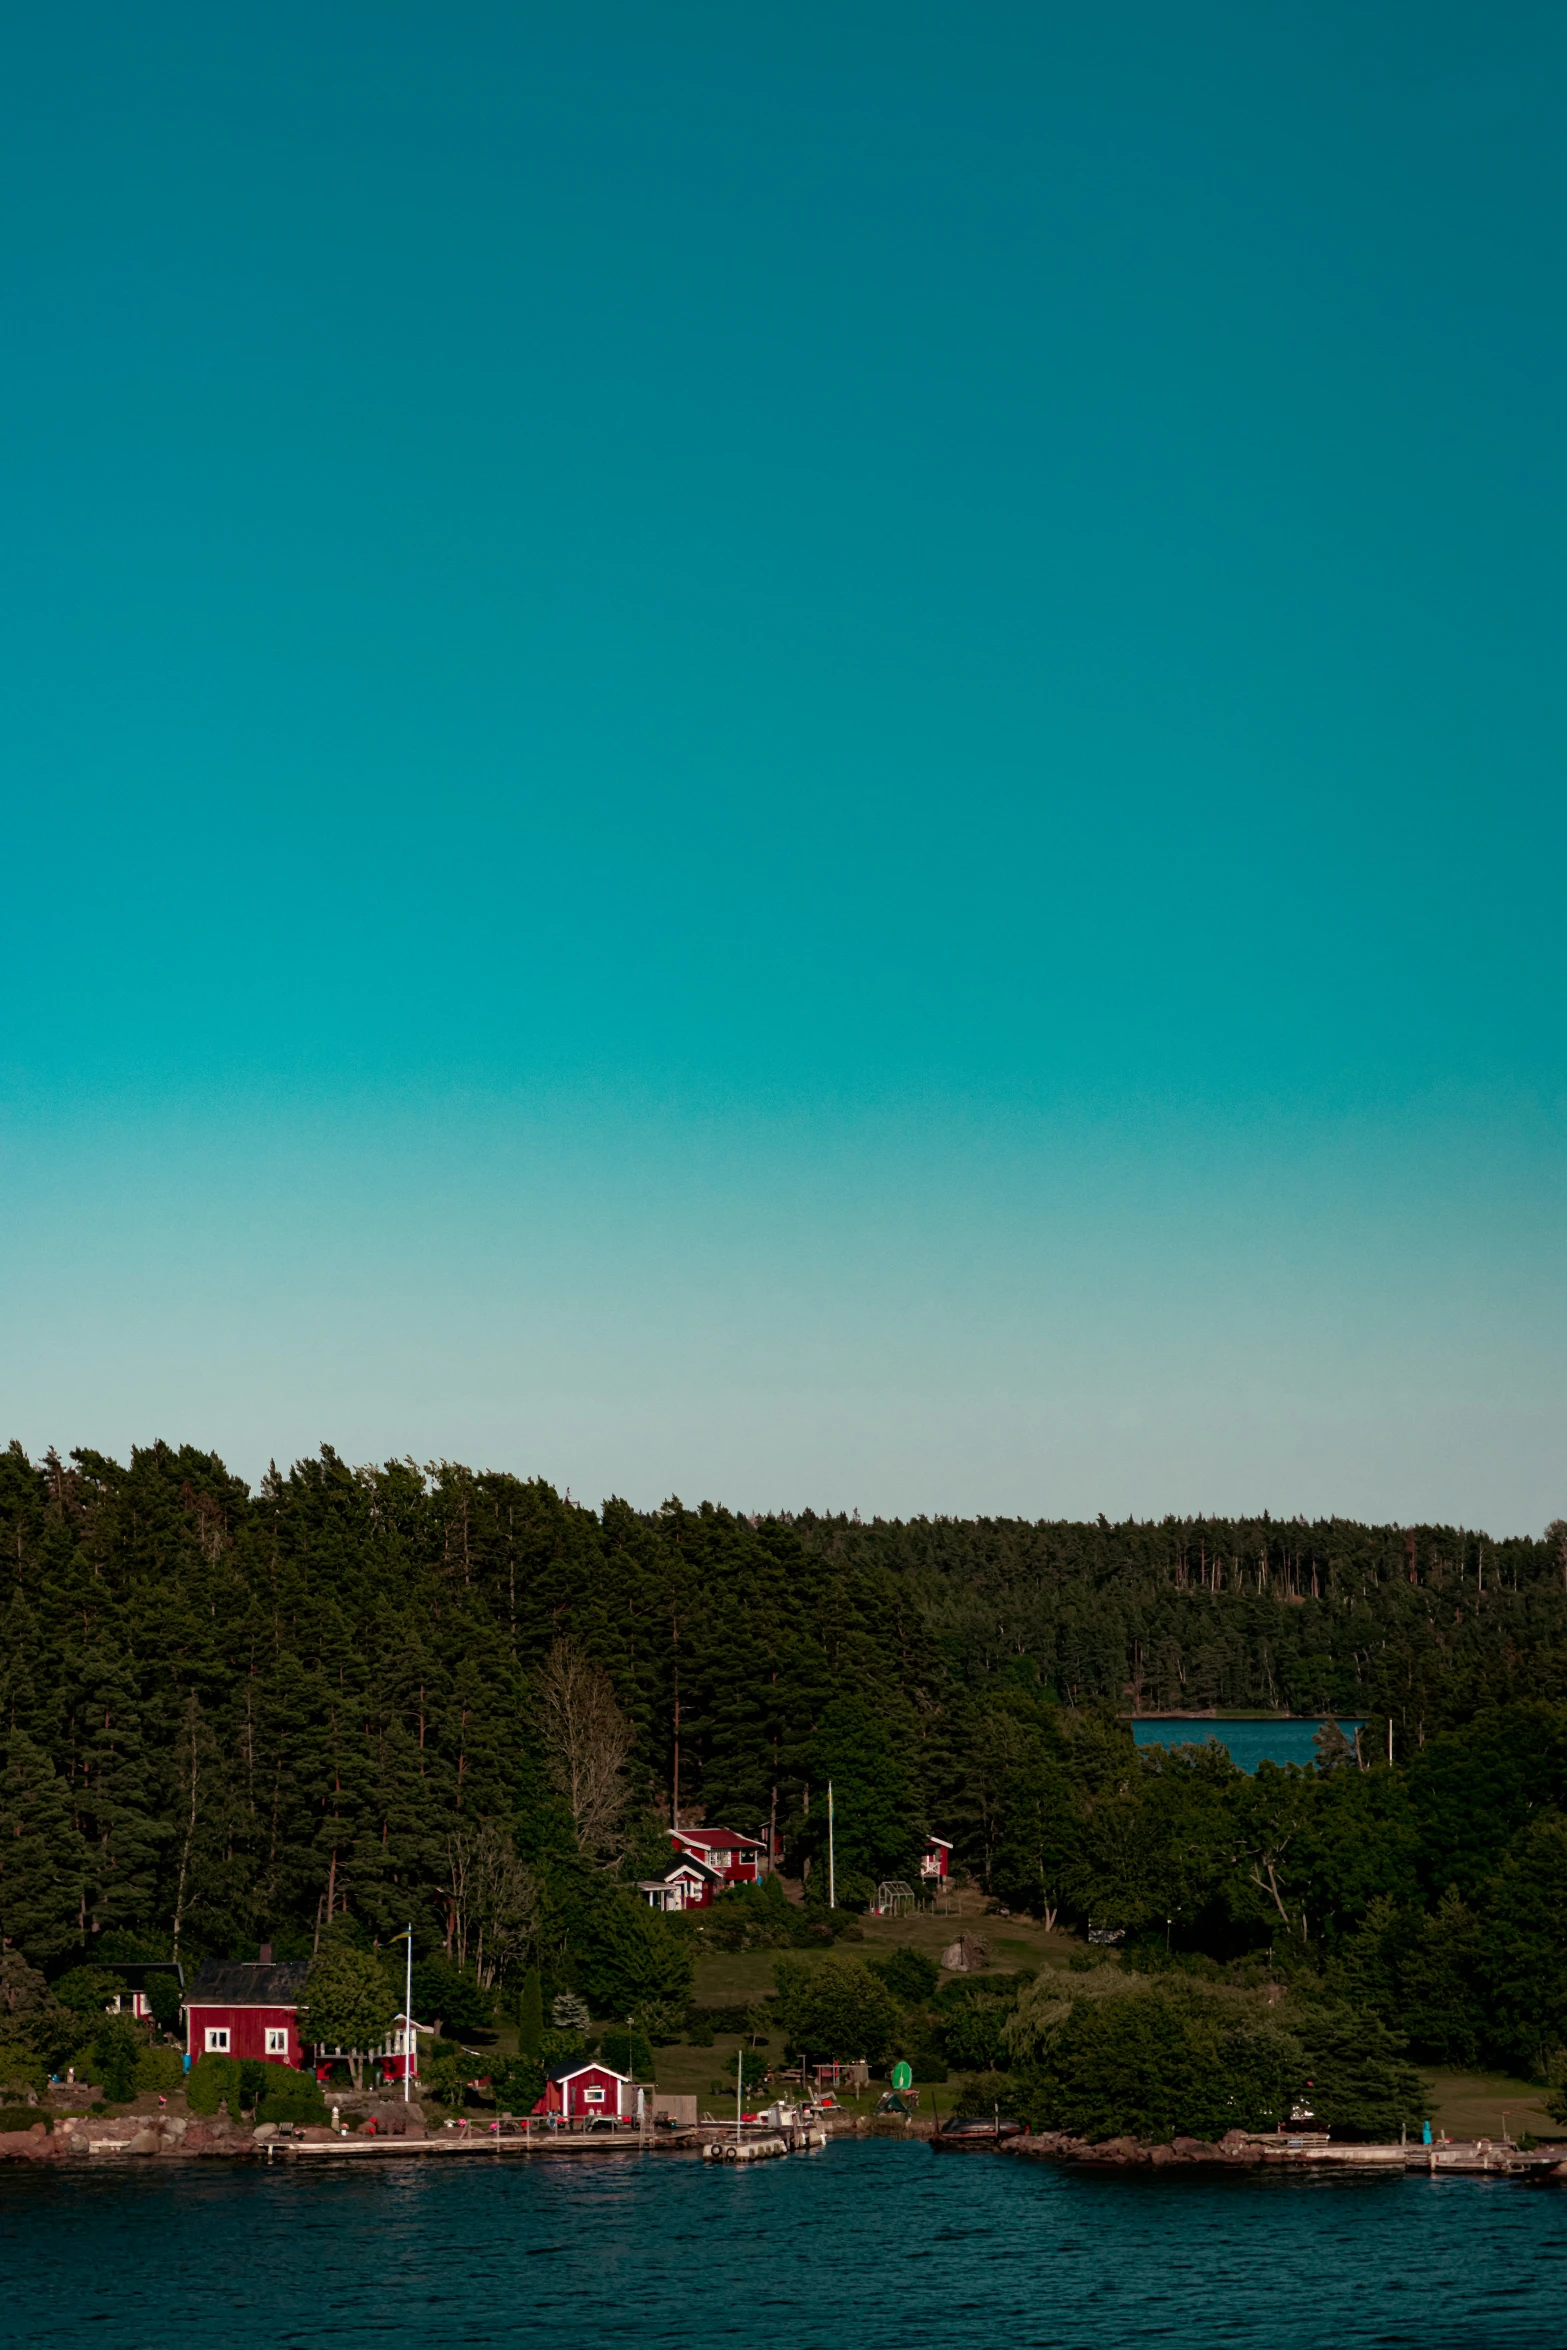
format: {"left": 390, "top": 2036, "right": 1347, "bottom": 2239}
{"left": 0, "top": 0, "right": 1567, "bottom": 1535}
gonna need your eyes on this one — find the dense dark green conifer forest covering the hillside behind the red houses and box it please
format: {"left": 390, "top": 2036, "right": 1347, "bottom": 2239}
{"left": 0, "top": 1445, "right": 1567, "bottom": 2124}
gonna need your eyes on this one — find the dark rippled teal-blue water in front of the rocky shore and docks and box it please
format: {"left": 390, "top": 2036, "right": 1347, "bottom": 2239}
{"left": 0, "top": 2143, "right": 1567, "bottom": 2350}
